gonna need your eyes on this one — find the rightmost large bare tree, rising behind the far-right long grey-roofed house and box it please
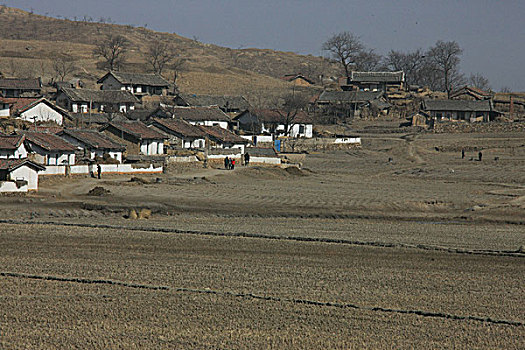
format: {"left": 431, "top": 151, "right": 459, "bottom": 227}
{"left": 426, "top": 40, "right": 464, "bottom": 97}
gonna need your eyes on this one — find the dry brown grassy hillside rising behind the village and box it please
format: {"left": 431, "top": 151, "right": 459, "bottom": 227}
{"left": 0, "top": 6, "right": 338, "bottom": 103}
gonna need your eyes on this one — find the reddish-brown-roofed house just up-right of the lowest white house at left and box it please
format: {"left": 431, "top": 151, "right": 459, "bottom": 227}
{"left": 21, "top": 131, "right": 78, "bottom": 165}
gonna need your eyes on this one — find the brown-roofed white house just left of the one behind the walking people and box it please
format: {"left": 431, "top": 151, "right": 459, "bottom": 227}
{"left": 151, "top": 118, "right": 206, "bottom": 148}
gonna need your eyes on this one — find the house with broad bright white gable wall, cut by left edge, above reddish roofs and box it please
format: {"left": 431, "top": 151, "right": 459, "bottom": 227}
{"left": 0, "top": 97, "right": 69, "bottom": 125}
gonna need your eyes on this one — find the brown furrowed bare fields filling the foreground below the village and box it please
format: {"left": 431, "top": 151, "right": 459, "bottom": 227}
{"left": 0, "top": 133, "right": 525, "bottom": 349}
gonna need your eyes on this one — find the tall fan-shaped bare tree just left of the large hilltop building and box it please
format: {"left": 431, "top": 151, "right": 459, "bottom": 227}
{"left": 322, "top": 32, "right": 364, "bottom": 77}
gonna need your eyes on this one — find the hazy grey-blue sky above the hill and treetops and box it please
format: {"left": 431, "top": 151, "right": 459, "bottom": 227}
{"left": 4, "top": 0, "right": 525, "bottom": 91}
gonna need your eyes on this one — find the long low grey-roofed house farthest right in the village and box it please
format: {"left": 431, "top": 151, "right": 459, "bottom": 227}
{"left": 421, "top": 100, "right": 501, "bottom": 122}
